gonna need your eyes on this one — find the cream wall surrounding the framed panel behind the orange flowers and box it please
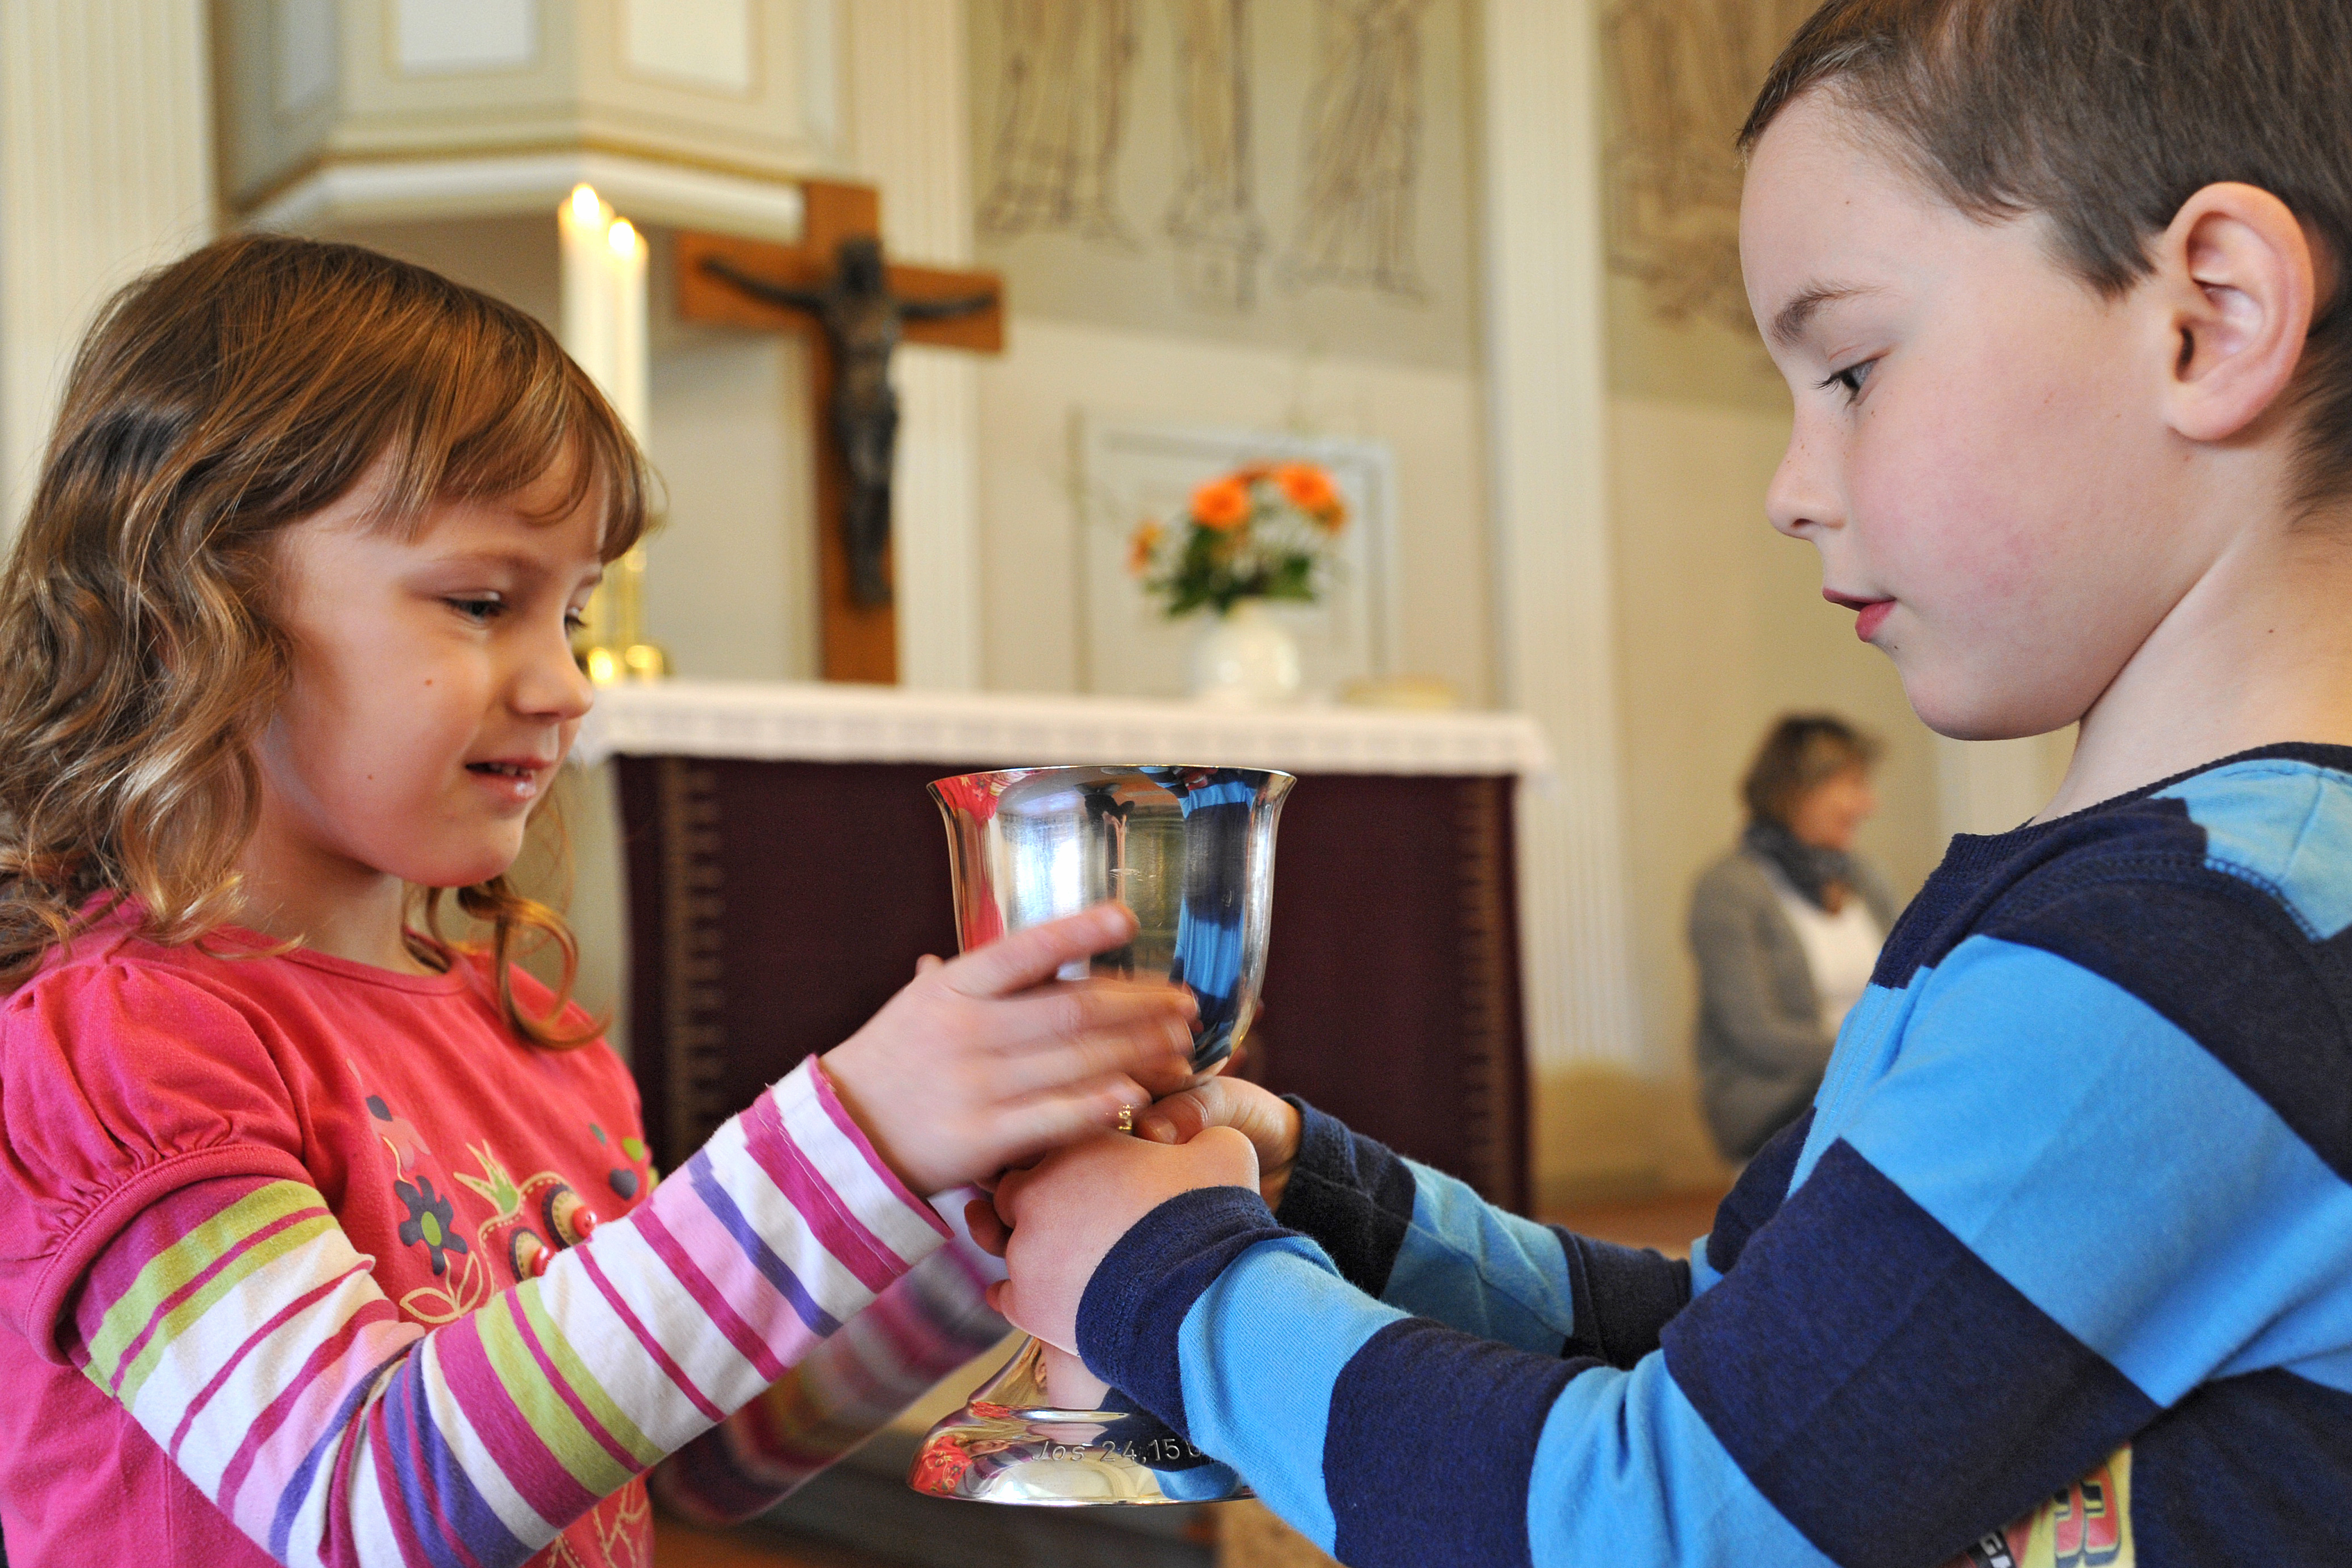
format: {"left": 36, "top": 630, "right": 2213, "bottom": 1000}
{"left": 981, "top": 315, "right": 1494, "bottom": 705}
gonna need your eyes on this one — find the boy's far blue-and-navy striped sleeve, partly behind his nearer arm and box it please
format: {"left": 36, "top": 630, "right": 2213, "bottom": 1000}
{"left": 1279, "top": 1098, "right": 1691, "bottom": 1366}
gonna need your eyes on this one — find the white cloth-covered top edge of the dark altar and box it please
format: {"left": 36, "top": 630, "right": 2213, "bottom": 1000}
{"left": 574, "top": 679, "right": 1550, "bottom": 776}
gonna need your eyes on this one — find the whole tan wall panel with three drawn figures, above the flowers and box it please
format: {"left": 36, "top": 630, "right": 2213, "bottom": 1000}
{"left": 967, "top": 0, "right": 1477, "bottom": 369}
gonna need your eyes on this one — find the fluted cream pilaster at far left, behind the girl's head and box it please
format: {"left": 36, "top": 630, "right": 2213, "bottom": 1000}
{"left": 0, "top": 0, "right": 214, "bottom": 536}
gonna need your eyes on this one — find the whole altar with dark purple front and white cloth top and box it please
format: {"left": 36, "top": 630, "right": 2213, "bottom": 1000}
{"left": 581, "top": 682, "right": 1546, "bottom": 1208}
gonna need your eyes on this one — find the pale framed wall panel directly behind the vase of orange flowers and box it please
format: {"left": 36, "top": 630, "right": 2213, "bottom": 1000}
{"left": 1077, "top": 414, "right": 1397, "bottom": 698}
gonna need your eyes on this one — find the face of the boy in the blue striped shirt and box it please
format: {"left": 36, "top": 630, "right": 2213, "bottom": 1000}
{"left": 1740, "top": 92, "right": 2213, "bottom": 738}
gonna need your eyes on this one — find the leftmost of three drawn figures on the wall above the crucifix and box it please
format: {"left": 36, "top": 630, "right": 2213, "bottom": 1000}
{"left": 979, "top": 0, "right": 1136, "bottom": 247}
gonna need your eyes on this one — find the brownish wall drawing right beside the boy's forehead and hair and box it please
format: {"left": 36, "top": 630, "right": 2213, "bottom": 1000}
{"left": 1602, "top": 0, "right": 1816, "bottom": 334}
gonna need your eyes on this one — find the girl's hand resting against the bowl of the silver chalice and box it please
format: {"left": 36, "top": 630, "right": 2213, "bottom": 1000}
{"left": 823, "top": 903, "right": 1200, "bottom": 1196}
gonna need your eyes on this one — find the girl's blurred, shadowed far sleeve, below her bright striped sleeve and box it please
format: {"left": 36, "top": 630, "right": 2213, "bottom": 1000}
{"left": 652, "top": 1187, "right": 1009, "bottom": 1525}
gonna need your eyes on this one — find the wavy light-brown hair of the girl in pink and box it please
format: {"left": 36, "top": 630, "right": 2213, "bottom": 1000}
{"left": 0, "top": 235, "right": 649, "bottom": 1046}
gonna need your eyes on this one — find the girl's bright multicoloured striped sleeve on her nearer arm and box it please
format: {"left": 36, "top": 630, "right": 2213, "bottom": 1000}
{"left": 59, "top": 1062, "right": 945, "bottom": 1566}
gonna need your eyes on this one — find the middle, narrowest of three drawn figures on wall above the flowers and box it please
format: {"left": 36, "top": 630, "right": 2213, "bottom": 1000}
{"left": 1167, "top": 0, "right": 1266, "bottom": 310}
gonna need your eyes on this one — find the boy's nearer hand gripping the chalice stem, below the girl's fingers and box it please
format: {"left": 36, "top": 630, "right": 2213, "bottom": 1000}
{"left": 988, "top": 1126, "right": 1258, "bottom": 1354}
